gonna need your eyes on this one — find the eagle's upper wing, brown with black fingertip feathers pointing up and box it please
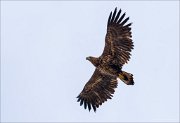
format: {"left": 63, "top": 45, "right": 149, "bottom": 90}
{"left": 101, "top": 8, "right": 134, "bottom": 66}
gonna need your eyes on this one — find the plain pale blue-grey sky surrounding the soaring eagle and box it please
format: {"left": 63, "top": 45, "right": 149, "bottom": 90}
{"left": 1, "top": 1, "right": 179, "bottom": 122}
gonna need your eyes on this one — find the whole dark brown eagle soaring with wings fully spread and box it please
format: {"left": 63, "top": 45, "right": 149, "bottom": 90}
{"left": 77, "top": 7, "right": 134, "bottom": 112}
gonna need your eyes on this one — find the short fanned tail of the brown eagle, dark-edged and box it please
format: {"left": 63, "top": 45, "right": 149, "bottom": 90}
{"left": 119, "top": 71, "right": 134, "bottom": 85}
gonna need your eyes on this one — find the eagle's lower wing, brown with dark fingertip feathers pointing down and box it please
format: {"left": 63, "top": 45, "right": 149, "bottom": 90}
{"left": 77, "top": 69, "right": 117, "bottom": 111}
